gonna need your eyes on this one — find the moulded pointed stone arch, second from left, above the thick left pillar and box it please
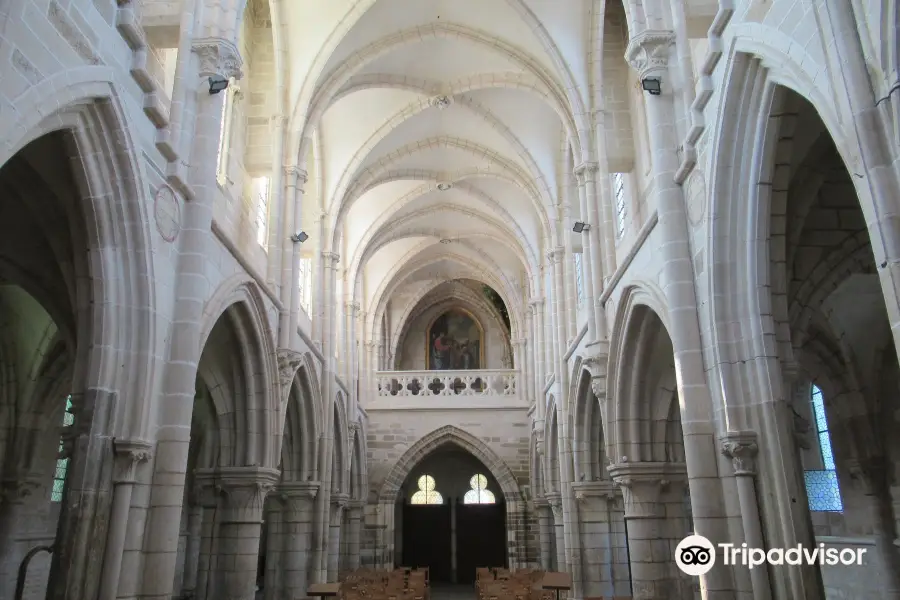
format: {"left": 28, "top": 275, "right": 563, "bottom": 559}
{"left": 197, "top": 275, "right": 283, "bottom": 468}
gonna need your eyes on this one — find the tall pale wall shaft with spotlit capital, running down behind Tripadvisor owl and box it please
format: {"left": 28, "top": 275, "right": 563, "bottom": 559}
{"left": 625, "top": 29, "right": 734, "bottom": 598}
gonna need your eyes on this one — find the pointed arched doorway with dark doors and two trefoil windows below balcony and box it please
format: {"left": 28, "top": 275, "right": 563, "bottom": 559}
{"left": 398, "top": 443, "right": 507, "bottom": 583}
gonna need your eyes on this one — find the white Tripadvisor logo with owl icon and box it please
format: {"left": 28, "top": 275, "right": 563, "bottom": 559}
{"left": 675, "top": 535, "right": 867, "bottom": 577}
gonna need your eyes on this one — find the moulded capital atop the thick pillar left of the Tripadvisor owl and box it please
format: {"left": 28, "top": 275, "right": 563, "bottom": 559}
{"left": 608, "top": 462, "right": 687, "bottom": 519}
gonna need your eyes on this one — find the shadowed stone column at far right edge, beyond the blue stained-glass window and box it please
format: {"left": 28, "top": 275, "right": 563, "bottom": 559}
{"left": 846, "top": 456, "right": 900, "bottom": 600}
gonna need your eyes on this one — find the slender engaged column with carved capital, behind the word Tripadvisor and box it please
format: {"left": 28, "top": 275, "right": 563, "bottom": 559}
{"left": 722, "top": 431, "right": 772, "bottom": 600}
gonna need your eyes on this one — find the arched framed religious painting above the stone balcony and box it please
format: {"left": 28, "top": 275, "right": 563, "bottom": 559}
{"left": 425, "top": 310, "right": 484, "bottom": 371}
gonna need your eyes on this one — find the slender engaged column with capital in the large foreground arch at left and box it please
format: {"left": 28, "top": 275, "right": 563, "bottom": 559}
{"left": 98, "top": 440, "right": 152, "bottom": 600}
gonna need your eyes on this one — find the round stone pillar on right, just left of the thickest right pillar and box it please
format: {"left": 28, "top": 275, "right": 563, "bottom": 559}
{"left": 572, "top": 481, "right": 627, "bottom": 598}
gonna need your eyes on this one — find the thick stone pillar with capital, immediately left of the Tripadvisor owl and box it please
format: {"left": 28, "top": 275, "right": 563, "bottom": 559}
{"left": 609, "top": 462, "right": 694, "bottom": 600}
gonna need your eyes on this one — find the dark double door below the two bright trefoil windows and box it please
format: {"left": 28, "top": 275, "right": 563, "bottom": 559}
{"left": 402, "top": 502, "right": 506, "bottom": 583}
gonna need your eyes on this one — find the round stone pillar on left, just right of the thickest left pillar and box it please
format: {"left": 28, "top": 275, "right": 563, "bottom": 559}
{"left": 278, "top": 481, "right": 319, "bottom": 598}
